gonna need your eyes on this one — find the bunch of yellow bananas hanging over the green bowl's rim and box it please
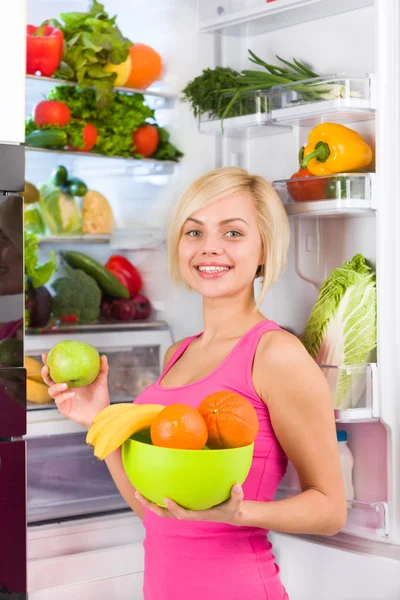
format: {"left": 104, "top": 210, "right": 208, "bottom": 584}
{"left": 86, "top": 404, "right": 165, "bottom": 460}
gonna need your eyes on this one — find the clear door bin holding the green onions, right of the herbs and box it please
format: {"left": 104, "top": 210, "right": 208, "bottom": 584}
{"left": 269, "top": 73, "right": 376, "bottom": 127}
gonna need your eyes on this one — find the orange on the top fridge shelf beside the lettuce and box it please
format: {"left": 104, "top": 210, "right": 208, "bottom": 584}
{"left": 125, "top": 44, "right": 162, "bottom": 90}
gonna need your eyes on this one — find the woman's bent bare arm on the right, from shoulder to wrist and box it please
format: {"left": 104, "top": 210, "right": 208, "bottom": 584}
{"left": 237, "top": 331, "right": 347, "bottom": 535}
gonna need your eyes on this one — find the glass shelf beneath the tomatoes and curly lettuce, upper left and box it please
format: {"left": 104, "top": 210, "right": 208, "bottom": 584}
{"left": 25, "top": 146, "right": 178, "bottom": 175}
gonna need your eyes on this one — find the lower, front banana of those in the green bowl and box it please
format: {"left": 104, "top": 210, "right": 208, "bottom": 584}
{"left": 94, "top": 404, "right": 165, "bottom": 460}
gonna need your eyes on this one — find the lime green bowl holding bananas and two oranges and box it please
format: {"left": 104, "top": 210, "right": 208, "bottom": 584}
{"left": 86, "top": 390, "right": 258, "bottom": 510}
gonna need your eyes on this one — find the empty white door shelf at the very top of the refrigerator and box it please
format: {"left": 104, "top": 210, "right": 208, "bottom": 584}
{"left": 197, "top": 0, "right": 374, "bottom": 36}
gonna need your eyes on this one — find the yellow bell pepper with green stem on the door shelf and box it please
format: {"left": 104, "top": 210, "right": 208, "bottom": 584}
{"left": 300, "top": 123, "right": 372, "bottom": 176}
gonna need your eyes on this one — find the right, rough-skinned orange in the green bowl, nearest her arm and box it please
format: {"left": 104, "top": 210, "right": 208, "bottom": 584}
{"left": 198, "top": 390, "right": 258, "bottom": 449}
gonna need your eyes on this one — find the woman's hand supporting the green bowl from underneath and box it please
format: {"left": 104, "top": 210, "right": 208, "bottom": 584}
{"left": 136, "top": 483, "right": 243, "bottom": 525}
